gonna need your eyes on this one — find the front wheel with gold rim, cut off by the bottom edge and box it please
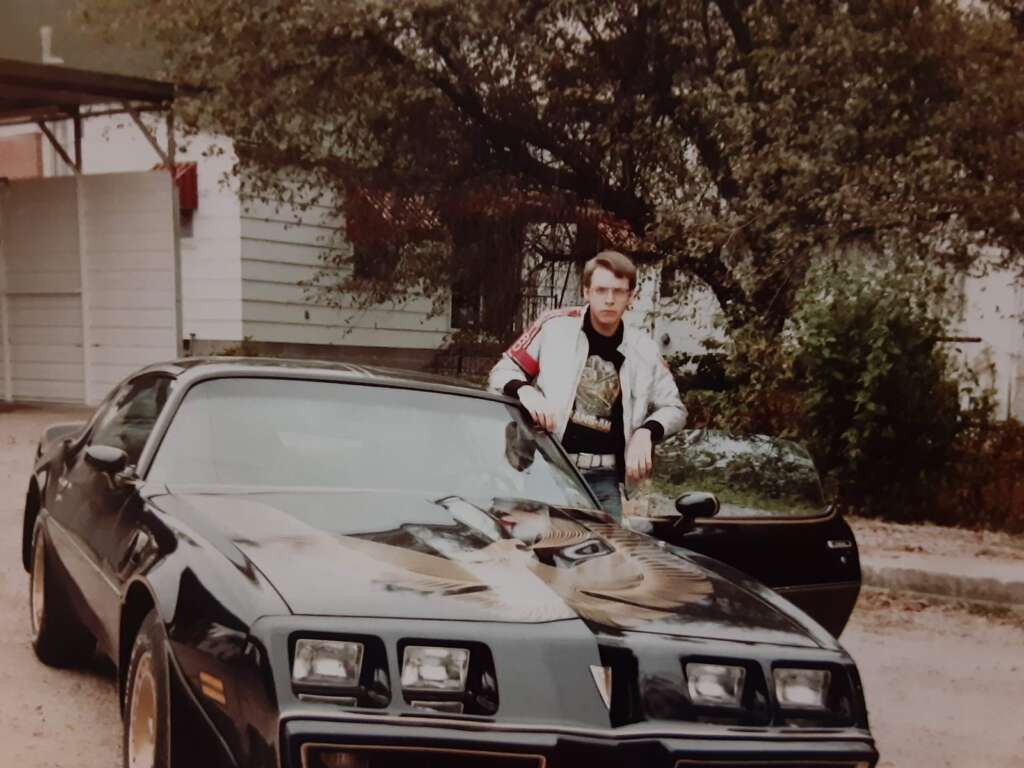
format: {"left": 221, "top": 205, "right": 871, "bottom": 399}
{"left": 122, "top": 611, "right": 171, "bottom": 768}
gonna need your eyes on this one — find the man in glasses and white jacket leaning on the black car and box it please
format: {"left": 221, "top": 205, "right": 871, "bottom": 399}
{"left": 489, "top": 251, "right": 686, "bottom": 520}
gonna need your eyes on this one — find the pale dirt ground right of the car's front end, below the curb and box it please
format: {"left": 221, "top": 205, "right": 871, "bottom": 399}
{"left": 841, "top": 590, "right": 1024, "bottom": 768}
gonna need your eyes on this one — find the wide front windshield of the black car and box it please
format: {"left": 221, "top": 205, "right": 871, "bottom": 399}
{"left": 148, "top": 378, "right": 595, "bottom": 509}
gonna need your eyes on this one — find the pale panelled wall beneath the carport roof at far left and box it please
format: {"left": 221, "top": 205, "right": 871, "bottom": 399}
{"left": 0, "top": 171, "right": 178, "bottom": 403}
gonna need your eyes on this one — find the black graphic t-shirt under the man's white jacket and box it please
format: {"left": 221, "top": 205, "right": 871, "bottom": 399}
{"left": 562, "top": 309, "right": 626, "bottom": 467}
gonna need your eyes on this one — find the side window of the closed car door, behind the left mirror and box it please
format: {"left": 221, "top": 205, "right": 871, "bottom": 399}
{"left": 91, "top": 376, "right": 173, "bottom": 465}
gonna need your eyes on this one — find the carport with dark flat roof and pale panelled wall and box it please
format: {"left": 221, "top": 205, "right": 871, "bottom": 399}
{"left": 0, "top": 59, "right": 182, "bottom": 403}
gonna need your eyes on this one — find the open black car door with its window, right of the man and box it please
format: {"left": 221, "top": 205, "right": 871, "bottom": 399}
{"left": 634, "top": 430, "right": 860, "bottom": 637}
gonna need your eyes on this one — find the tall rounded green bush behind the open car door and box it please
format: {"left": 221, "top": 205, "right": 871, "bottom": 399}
{"left": 793, "top": 259, "right": 989, "bottom": 519}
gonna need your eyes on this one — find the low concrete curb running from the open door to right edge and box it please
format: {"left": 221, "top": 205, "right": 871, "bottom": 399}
{"left": 860, "top": 556, "right": 1024, "bottom": 606}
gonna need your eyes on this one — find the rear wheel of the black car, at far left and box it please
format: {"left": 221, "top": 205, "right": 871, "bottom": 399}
{"left": 29, "top": 521, "right": 96, "bottom": 668}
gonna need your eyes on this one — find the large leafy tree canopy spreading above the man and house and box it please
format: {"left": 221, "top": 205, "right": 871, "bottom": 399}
{"left": 83, "top": 0, "right": 1024, "bottom": 335}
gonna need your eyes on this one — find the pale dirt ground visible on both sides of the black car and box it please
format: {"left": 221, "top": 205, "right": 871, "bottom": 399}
{"left": 0, "top": 406, "right": 1024, "bottom": 768}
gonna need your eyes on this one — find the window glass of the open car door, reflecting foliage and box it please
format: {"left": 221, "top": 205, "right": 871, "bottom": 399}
{"left": 666, "top": 429, "right": 825, "bottom": 517}
